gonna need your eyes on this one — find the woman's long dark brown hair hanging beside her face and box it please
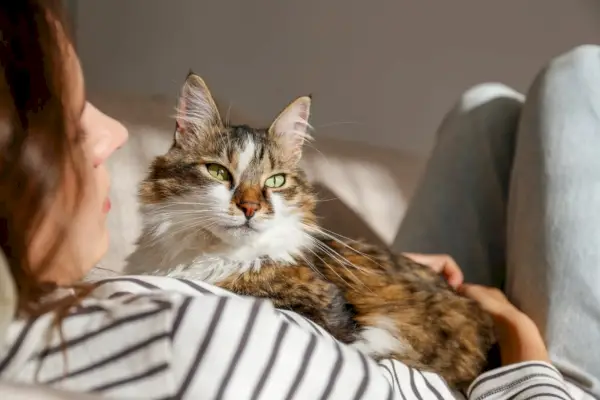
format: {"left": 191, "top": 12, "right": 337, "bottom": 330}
{"left": 0, "top": 0, "right": 83, "bottom": 314}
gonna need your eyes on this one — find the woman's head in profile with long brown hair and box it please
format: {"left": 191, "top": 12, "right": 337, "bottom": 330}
{"left": 0, "top": 0, "right": 127, "bottom": 307}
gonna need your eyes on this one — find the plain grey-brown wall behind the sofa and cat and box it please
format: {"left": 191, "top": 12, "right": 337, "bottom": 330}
{"left": 76, "top": 0, "right": 600, "bottom": 153}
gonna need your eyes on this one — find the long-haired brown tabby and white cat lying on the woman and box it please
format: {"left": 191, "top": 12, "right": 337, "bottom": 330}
{"left": 125, "top": 72, "right": 494, "bottom": 389}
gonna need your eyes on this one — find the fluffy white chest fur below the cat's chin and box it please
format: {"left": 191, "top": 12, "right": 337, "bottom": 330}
{"left": 125, "top": 198, "right": 312, "bottom": 283}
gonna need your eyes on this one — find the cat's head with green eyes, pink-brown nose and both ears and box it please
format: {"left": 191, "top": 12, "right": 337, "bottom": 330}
{"left": 140, "top": 73, "right": 315, "bottom": 250}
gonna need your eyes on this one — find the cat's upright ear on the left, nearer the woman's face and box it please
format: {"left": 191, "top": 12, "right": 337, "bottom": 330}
{"left": 175, "top": 71, "right": 223, "bottom": 144}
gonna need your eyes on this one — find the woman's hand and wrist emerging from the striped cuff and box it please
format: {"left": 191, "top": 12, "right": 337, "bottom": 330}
{"left": 458, "top": 284, "right": 550, "bottom": 365}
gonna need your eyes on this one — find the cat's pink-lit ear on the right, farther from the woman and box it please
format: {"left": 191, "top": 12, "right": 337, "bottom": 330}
{"left": 269, "top": 96, "right": 312, "bottom": 162}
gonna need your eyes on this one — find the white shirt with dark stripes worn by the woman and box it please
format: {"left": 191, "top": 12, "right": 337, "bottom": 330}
{"left": 0, "top": 276, "right": 591, "bottom": 400}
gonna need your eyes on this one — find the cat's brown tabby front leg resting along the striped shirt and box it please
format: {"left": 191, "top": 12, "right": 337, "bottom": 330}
{"left": 218, "top": 266, "right": 356, "bottom": 343}
